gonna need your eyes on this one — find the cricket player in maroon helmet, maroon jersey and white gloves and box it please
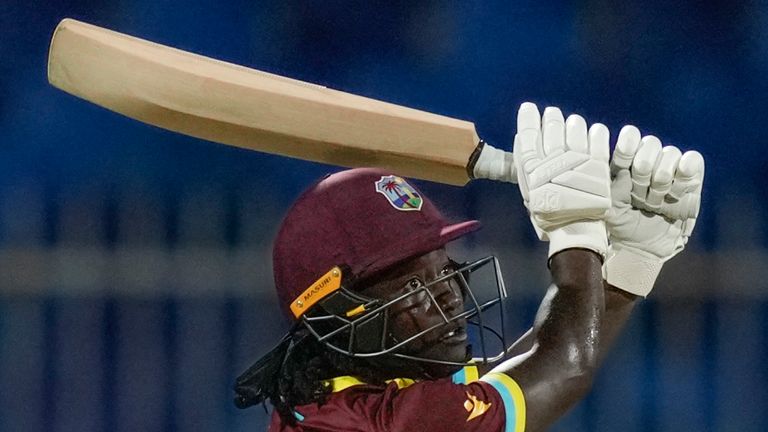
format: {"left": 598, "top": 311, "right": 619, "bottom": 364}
{"left": 236, "top": 103, "right": 704, "bottom": 432}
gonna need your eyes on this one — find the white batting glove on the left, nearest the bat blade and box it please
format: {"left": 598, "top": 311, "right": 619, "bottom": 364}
{"left": 514, "top": 102, "right": 611, "bottom": 257}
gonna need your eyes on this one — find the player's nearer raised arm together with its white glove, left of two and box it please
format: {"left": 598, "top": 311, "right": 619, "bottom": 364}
{"left": 484, "top": 104, "right": 611, "bottom": 431}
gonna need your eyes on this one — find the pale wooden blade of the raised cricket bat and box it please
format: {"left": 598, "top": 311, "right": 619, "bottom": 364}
{"left": 48, "top": 19, "right": 510, "bottom": 185}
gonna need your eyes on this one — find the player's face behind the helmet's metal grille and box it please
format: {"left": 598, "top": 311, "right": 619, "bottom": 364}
{"left": 364, "top": 249, "right": 469, "bottom": 372}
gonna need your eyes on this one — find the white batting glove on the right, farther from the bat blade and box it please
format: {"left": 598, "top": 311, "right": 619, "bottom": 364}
{"left": 605, "top": 126, "right": 704, "bottom": 297}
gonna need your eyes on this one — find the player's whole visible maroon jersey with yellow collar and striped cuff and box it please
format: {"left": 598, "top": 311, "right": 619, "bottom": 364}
{"left": 269, "top": 366, "right": 525, "bottom": 432}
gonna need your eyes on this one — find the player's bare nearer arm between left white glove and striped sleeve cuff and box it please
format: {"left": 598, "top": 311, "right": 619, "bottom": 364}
{"left": 494, "top": 249, "right": 605, "bottom": 430}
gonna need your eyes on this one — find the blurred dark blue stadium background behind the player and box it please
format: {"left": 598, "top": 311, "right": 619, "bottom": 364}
{"left": 0, "top": 0, "right": 768, "bottom": 432}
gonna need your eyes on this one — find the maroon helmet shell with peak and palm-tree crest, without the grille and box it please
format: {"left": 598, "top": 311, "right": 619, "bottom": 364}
{"left": 273, "top": 168, "right": 480, "bottom": 318}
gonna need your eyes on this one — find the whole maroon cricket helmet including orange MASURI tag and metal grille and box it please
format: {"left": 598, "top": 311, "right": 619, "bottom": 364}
{"left": 273, "top": 168, "right": 506, "bottom": 364}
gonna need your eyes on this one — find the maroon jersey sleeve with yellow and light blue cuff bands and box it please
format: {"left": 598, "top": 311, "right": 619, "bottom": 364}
{"left": 369, "top": 368, "right": 525, "bottom": 432}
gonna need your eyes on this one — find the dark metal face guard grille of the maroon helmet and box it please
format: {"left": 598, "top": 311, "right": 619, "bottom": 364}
{"left": 300, "top": 256, "right": 508, "bottom": 366}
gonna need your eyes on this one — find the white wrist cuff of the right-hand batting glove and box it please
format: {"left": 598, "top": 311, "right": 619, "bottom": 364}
{"left": 605, "top": 245, "right": 666, "bottom": 297}
